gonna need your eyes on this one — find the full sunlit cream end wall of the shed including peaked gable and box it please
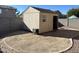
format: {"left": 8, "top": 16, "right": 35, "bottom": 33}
{"left": 23, "top": 7, "right": 39, "bottom": 31}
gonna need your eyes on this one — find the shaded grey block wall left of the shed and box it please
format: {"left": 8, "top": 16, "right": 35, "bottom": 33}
{"left": 0, "top": 17, "right": 22, "bottom": 35}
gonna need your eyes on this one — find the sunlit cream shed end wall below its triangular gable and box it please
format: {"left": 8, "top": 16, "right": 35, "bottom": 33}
{"left": 23, "top": 13, "right": 39, "bottom": 31}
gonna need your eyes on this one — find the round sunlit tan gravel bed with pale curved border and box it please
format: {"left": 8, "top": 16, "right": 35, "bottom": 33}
{"left": 1, "top": 32, "right": 72, "bottom": 53}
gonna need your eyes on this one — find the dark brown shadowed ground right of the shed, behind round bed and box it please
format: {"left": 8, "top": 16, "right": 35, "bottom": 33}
{"left": 41, "top": 29, "right": 79, "bottom": 39}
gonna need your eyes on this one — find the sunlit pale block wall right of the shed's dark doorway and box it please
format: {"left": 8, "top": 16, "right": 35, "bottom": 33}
{"left": 58, "top": 18, "right": 79, "bottom": 29}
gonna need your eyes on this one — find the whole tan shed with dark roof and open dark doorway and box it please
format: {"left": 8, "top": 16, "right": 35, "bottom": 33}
{"left": 22, "top": 7, "right": 58, "bottom": 33}
